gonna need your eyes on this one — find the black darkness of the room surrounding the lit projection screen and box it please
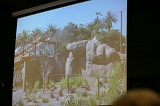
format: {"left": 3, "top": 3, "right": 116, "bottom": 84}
{"left": 0, "top": 0, "right": 160, "bottom": 106}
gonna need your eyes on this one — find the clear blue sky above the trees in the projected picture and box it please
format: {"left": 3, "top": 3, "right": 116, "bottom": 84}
{"left": 17, "top": 0, "right": 127, "bottom": 35}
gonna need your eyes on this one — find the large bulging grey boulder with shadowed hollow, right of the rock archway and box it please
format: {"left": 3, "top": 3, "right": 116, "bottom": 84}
{"left": 83, "top": 38, "right": 121, "bottom": 77}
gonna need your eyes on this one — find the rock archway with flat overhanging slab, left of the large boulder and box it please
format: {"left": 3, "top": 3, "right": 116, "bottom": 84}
{"left": 65, "top": 40, "right": 88, "bottom": 75}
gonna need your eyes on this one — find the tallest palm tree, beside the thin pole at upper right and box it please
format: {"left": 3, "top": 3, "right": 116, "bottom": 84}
{"left": 104, "top": 11, "right": 117, "bottom": 31}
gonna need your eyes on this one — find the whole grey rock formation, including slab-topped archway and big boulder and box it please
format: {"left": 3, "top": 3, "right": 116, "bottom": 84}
{"left": 65, "top": 38, "right": 125, "bottom": 77}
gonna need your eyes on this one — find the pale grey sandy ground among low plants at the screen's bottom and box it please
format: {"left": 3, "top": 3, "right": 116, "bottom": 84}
{"left": 12, "top": 81, "right": 108, "bottom": 106}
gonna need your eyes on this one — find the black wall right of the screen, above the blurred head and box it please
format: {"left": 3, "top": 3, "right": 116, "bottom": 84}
{"left": 127, "top": 0, "right": 160, "bottom": 93}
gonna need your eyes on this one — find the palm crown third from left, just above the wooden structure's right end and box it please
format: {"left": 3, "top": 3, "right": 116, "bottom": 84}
{"left": 46, "top": 24, "right": 57, "bottom": 36}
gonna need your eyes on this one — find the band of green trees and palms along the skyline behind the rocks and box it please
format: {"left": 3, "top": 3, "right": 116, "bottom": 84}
{"left": 16, "top": 11, "right": 126, "bottom": 52}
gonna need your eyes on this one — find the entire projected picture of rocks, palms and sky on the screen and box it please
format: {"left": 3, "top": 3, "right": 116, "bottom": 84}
{"left": 12, "top": 0, "right": 127, "bottom": 106}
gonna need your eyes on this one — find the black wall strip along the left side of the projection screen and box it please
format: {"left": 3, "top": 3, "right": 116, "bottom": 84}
{"left": 0, "top": 3, "right": 16, "bottom": 106}
